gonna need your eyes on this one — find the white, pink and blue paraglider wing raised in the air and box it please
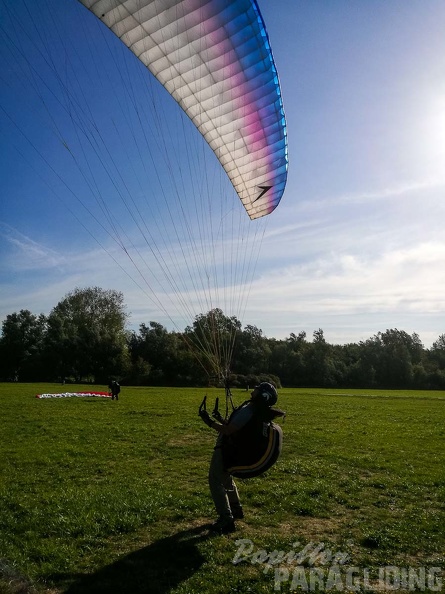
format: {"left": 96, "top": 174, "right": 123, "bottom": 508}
{"left": 80, "top": 0, "right": 288, "bottom": 219}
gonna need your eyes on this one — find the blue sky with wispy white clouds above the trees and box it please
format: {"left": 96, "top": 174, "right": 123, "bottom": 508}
{"left": 0, "top": 0, "right": 445, "bottom": 347}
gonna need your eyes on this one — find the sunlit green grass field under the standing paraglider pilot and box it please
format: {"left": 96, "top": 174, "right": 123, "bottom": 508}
{"left": 0, "top": 384, "right": 445, "bottom": 594}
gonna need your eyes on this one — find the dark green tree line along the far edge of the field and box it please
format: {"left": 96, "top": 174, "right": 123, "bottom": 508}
{"left": 0, "top": 287, "right": 445, "bottom": 390}
